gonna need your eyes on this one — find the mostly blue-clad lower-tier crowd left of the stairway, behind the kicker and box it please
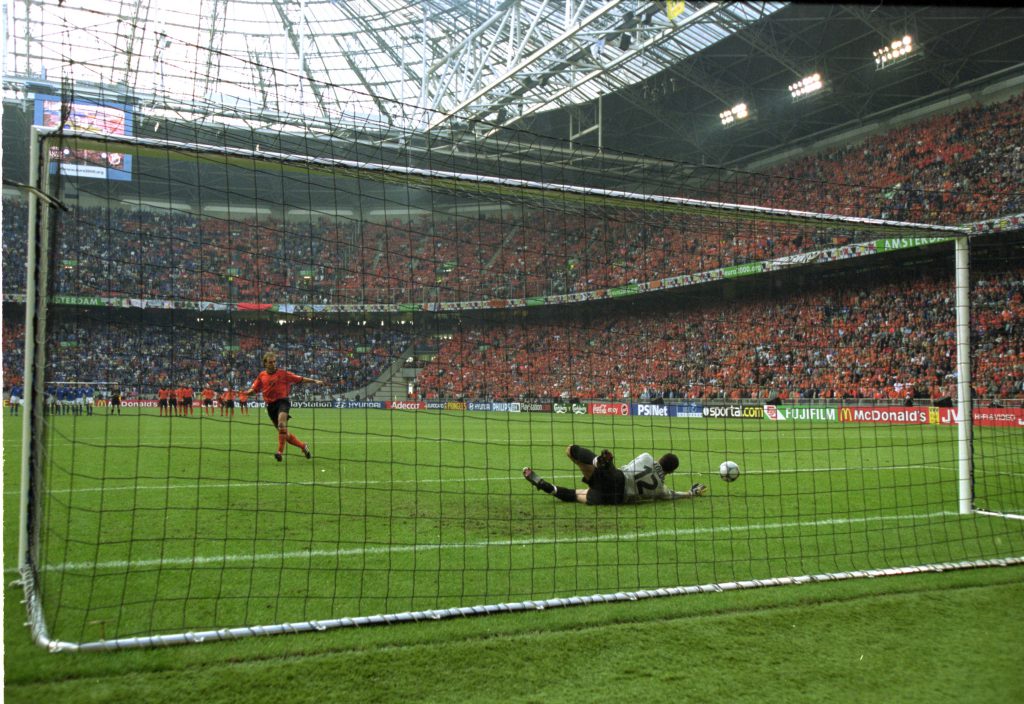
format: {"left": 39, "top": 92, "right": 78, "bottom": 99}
{"left": 3, "top": 315, "right": 413, "bottom": 396}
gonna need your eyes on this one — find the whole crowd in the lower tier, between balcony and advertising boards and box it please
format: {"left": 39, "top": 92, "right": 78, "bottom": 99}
{"left": 3, "top": 263, "right": 1024, "bottom": 402}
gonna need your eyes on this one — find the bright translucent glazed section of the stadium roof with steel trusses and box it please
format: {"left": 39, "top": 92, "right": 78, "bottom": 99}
{"left": 4, "top": 0, "right": 785, "bottom": 141}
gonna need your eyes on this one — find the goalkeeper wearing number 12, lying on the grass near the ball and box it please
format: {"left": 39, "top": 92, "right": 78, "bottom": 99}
{"left": 522, "top": 445, "right": 708, "bottom": 505}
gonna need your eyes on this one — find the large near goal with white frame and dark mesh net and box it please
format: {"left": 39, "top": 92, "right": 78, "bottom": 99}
{"left": 4, "top": 105, "right": 1024, "bottom": 650}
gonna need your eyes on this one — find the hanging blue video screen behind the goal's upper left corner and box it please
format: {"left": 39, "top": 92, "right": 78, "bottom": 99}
{"left": 35, "top": 95, "right": 132, "bottom": 181}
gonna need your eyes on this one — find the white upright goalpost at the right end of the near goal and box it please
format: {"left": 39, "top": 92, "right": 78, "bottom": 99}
{"left": 955, "top": 237, "right": 974, "bottom": 515}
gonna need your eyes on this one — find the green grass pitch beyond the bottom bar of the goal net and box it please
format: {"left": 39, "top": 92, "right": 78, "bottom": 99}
{"left": 5, "top": 409, "right": 1024, "bottom": 642}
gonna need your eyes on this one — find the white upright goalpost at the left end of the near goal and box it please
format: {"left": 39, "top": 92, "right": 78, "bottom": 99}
{"left": 17, "top": 127, "right": 50, "bottom": 573}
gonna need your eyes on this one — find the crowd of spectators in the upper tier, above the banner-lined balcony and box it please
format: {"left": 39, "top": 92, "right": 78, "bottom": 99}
{"left": 3, "top": 95, "right": 1024, "bottom": 304}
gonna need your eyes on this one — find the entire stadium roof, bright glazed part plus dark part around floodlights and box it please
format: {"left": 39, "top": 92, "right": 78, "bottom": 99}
{"left": 3, "top": 0, "right": 1024, "bottom": 184}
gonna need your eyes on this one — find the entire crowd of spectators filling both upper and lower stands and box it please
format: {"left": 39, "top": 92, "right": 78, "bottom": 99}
{"left": 3, "top": 94, "right": 1024, "bottom": 399}
